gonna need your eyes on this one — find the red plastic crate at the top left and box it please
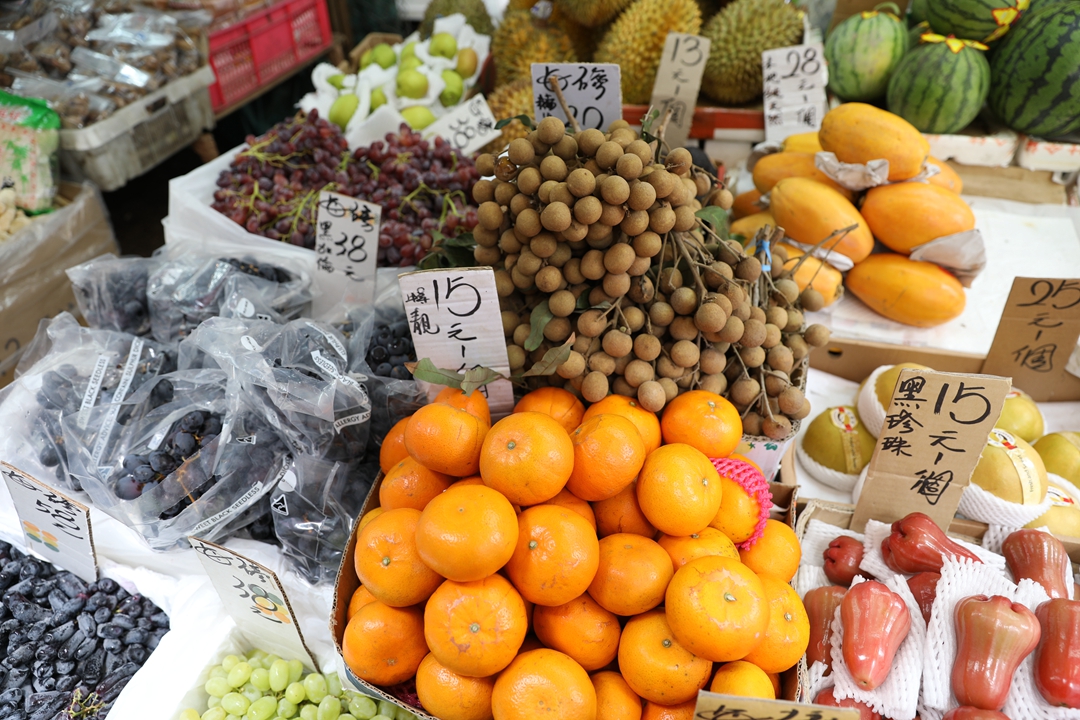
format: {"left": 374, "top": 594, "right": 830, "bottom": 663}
{"left": 210, "top": 0, "right": 330, "bottom": 112}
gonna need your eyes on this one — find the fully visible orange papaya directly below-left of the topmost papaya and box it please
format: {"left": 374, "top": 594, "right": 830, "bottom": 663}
{"left": 769, "top": 177, "right": 874, "bottom": 262}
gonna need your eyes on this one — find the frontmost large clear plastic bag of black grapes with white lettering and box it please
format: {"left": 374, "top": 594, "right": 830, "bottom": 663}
{"left": 64, "top": 370, "right": 292, "bottom": 551}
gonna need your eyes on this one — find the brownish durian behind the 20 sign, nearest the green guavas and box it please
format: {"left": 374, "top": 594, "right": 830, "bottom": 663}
{"left": 491, "top": 10, "right": 578, "bottom": 85}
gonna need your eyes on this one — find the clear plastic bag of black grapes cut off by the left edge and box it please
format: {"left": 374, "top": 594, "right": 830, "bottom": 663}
{"left": 0, "top": 313, "right": 175, "bottom": 490}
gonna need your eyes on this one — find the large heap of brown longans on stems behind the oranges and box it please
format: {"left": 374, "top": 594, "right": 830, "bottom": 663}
{"left": 473, "top": 118, "right": 824, "bottom": 437}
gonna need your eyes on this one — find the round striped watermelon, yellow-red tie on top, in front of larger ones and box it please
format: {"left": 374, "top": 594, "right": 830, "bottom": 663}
{"left": 888, "top": 38, "right": 990, "bottom": 134}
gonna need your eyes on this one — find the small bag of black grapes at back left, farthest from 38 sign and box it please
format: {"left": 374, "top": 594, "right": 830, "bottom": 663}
{"left": 67, "top": 253, "right": 163, "bottom": 335}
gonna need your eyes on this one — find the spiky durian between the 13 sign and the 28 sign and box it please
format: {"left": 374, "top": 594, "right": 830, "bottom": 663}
{"left": 701, "top": 0, "right": 802, "bottom": 105}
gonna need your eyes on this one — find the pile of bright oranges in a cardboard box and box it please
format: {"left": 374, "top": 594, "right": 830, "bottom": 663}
{"left": 342, "top": 388, "right": 809, "bottom": 720}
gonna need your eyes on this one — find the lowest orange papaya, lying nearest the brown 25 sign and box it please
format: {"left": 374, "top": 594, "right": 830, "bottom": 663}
{"left": 847, "top": 253, "right": 966, "bottom": 327}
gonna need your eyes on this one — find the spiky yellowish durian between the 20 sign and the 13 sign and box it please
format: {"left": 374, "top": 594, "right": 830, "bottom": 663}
{"left": 593, "top": 0, "right": 701, "bottom": 105}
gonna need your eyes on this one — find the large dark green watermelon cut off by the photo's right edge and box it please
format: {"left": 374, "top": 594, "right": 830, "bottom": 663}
{"left": 989, "top": 0, "right": 1080, "bottom": 137}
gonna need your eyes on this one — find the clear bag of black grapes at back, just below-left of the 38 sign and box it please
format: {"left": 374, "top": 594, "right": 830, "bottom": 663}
{"left": 146, "top": 257, "right": 312, "bottom": 342}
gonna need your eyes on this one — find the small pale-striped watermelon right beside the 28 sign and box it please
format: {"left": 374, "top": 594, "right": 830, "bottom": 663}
{"left": 825, "top": 3, "right": 907, "bottom": 100}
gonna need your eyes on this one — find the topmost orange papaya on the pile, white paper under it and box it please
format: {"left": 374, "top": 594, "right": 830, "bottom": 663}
{"left": 818, "top": 103, "right": 930, "bottom": 182}
